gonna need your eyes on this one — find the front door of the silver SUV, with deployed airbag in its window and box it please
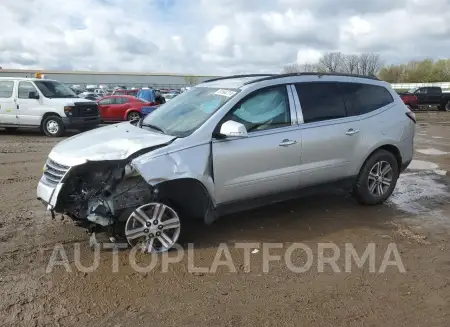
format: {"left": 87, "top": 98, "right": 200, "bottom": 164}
{"left": 212, "top": 85, "right": 302, "bottom": 204}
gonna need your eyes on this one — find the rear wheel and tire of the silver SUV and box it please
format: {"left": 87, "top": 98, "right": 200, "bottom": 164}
{"left": 353, "top": 150, "right": 399, "bottom": 205}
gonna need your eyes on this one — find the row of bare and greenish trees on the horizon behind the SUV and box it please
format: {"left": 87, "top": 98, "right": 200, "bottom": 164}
{"left": 282, "top": 52, "right": 450, "bottom": 83}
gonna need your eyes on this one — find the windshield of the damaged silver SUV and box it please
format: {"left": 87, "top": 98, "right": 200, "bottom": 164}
{"left": 142, "top": 87, "right": 239, "bottom": 137}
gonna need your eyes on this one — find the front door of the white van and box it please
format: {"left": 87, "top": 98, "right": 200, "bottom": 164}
{"left": 16, "top": 82, "right": 42, "bottom": 126}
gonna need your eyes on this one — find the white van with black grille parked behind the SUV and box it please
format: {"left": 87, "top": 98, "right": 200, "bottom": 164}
{"left": 0, "top": 77, "right": 101, "bottom": 137}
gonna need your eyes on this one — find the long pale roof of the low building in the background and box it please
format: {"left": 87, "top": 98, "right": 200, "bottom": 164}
{"left": 0, "top": 69, "right": 217, "bottom": 78}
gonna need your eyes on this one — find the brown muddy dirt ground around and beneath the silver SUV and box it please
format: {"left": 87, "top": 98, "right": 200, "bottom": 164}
{"left": 0, "top": 113, "right": 450, "bottom": 327}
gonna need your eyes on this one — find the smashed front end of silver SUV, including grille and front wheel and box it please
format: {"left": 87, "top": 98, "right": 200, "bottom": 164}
{"left": 38, "top": 153, "right": 179, "bottom": 252}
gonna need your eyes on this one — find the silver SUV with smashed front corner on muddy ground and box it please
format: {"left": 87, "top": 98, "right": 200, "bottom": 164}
{"left": 37, "top": 73, "right": 415, "bottom": 252}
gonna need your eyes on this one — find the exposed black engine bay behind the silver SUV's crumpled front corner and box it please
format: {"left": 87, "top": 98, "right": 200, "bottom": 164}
{"left": 55, "top": 161, "right": 153, "bottom": 226}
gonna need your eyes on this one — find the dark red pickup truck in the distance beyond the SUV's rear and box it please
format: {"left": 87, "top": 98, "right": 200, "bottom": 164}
{"left": 399, "top": 86, "right": 450, "bottom": 111}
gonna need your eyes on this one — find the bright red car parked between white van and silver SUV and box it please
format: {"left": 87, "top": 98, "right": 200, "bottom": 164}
{"left": 97, "top": 95, "right": 153, "bottom": 121}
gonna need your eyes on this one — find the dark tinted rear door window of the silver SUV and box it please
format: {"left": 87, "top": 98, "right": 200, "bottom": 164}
{"left": 295, "top": 82, "right": 347, "bottom": 123}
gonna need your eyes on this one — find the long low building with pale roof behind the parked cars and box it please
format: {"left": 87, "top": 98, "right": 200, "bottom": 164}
{"left": 0, "top": 69, "right": 220, "bottom": 88}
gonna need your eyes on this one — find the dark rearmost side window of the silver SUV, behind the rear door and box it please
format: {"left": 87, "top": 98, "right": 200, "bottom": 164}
{"left": 339, "top": 83, "right": 394, "bottom": 116}
